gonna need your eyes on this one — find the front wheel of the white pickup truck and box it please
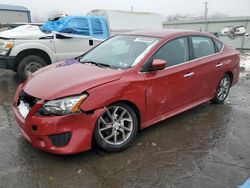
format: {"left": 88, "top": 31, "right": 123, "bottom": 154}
{"left": 17, "top": 55, "right": 47, "bottom": 81}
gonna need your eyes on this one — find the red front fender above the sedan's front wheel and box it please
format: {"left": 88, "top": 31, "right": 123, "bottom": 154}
{"left": 81, "top": 77, "right": 146, "bottom": 126}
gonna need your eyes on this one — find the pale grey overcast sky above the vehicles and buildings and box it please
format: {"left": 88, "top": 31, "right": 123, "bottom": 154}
{"left": 0, "top": 0, "right": 250, "bottom": 18}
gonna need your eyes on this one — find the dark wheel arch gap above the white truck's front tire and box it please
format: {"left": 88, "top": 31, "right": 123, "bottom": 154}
{"left": 14, "top": 48, "right": 52, "bottom": 71}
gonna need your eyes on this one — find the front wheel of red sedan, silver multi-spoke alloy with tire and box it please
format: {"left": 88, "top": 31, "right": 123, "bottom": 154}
{"left": 93, "top": 103, "right": 138, "bottom": 152}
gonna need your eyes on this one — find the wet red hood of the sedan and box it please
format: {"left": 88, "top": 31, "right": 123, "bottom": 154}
{"left": 23, "top": 59, "right": 124, "bottom": 100}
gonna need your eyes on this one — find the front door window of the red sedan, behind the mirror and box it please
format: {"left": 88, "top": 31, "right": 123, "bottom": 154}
{"left": 153, "top": 37, "right": 189, "bottom": 67}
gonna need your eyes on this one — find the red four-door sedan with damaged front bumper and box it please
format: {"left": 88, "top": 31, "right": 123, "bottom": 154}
{"left": 13, "top": 30, "right": 239, "bottom": 154}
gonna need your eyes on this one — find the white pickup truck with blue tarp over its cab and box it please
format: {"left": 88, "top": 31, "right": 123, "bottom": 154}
{"left": 0, "top": 16, "right": 108, "bottom": 80}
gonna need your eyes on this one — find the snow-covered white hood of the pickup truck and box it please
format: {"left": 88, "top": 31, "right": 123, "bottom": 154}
{"left": 0, "top": 25, "right": 47, "bottom": 39}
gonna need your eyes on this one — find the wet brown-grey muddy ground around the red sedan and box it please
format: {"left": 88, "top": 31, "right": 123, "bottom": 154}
{"left": 0, "top": 69, "right": 250, "bottom": 188}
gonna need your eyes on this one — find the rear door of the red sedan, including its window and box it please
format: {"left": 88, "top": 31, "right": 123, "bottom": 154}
{"left": 190, "top": 36, "right": 223, "bottom": 103}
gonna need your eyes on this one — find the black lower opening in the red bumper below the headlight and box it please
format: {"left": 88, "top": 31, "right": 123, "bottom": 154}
{"left": 49, "top": 132, "right": 71, "bottom": 147}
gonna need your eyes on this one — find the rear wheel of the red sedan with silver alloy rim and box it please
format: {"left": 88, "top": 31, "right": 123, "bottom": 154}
{"left": 211, "top": 74, "right": 231, "bottom": 104}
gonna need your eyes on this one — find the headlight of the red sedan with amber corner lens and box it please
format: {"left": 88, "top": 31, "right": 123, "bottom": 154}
{"left": 38, "top": 93, "right": 88, "bottom": 116}
